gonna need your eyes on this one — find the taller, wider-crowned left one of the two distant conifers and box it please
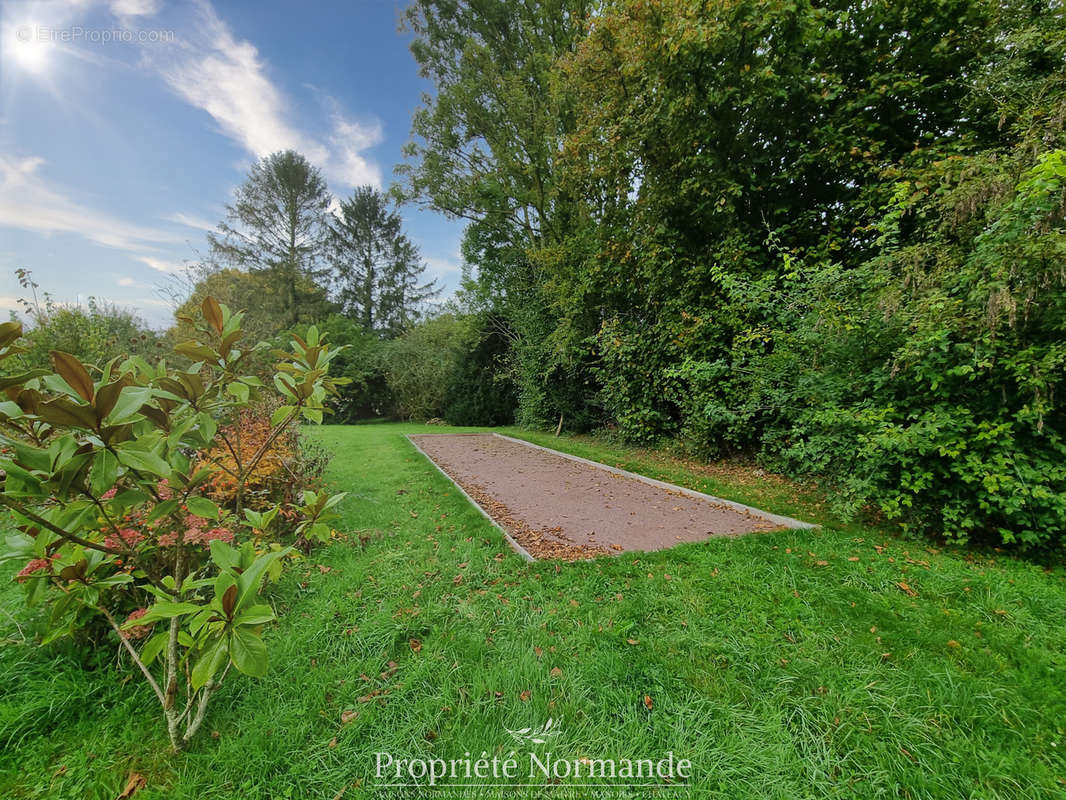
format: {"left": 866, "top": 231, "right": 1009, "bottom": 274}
{"left": 208, "top": 150, "right": 329, "bottom": 325}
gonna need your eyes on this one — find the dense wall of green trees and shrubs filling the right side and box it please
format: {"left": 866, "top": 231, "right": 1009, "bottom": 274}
{"left": 405, "top": 0, "right": 1066, "bottom": 548}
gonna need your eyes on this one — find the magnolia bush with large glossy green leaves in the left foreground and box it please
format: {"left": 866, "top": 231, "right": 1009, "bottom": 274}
{"left": 0, "top": 298, "right": 343, "bottom": 751}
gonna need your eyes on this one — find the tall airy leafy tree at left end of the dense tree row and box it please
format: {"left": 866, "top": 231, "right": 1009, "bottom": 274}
{"left": 398, "top": 0, "right": 599, "bottom": 422}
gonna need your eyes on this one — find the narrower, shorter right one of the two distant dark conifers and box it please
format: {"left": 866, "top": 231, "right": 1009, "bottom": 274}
{"left": 330, "top": 186, "right": 438, "bottom": 336}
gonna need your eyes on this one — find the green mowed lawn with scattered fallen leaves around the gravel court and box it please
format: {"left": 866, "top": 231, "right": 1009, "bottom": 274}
{"left": 0, "top": 425, "right": 1066, "bottom": 800}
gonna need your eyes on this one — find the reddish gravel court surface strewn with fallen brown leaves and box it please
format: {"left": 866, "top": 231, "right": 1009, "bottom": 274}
{"left": 410, "top": 433, "right": 778, "bottom": 559}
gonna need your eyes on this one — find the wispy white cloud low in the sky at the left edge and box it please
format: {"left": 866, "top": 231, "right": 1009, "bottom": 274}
{"left": 0, "top": 154, "right": 181, "bottom": 252}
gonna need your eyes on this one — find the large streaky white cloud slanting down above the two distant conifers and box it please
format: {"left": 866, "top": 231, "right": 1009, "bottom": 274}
{"left": 145, "top": 0, "right": 384, "bottom": 186}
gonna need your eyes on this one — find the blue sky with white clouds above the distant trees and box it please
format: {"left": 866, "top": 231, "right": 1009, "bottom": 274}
{"left": 0, "top": 0, "right": 463, "bottom": 327}
